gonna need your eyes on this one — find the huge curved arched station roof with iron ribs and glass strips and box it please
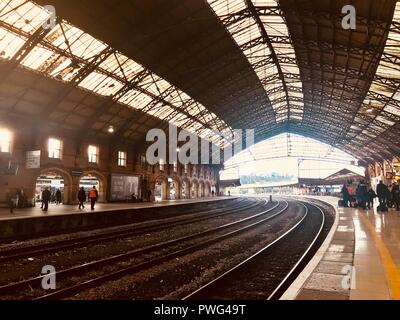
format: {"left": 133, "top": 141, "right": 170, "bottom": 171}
{"left": 0, "top": 0, "right": 400, "bottom": 162}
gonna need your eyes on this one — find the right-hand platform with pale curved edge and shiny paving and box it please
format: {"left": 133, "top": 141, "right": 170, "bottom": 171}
{"left": 281, "top": 196, "right": 400, "bottom": 300}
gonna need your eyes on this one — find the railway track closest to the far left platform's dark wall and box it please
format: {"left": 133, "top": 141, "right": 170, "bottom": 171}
{"left": 0, "top": 200, "right": 258, "bottom": 263}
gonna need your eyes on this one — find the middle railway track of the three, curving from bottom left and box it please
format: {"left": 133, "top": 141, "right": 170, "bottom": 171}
{"left": 0, "top": 201, "right": 289, "bottom": 299}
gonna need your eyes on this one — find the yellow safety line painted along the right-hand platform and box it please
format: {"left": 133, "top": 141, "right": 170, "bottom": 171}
{"left": 359, "top": 213, "right": 400, "bottom": 300}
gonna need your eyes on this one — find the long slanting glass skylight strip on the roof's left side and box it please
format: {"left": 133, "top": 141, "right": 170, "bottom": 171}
{"left": 0, "top": 0, "right": 231, "bottom": 143}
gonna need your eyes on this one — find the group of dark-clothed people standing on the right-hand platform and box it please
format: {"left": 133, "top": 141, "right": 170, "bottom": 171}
{"left": 341, "top": 181, "right": 400, "bottom": 211}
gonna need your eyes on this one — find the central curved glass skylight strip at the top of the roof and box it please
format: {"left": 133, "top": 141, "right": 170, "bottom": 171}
{"left": 207, "top": 0, "right": 304, "bottom": 123}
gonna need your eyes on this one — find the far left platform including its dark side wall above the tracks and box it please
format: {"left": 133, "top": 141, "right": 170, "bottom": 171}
{"left": 0, "top": 196, "right": 236, "bottom": 241}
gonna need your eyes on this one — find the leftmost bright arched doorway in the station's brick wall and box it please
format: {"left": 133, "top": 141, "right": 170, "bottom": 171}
{"left": 34, "top": 167, "right": 72, "bottom": 204}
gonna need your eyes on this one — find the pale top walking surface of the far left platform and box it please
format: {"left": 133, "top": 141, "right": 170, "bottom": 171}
{"left": 0, "top": 196, "right": 236, "bottom": 221}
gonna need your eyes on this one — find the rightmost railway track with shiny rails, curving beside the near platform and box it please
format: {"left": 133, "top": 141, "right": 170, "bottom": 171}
{"left": 183, "top": 200, "right": 326, "bottom": 300}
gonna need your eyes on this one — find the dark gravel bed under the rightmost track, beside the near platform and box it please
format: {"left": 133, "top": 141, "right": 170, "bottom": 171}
{"left": 187, "top": 202, "right": 334, "bottom": 300}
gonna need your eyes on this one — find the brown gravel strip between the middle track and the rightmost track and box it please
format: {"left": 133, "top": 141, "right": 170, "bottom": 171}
{"left": 64, "top": 200, "right": 304, "bottom": 299}
